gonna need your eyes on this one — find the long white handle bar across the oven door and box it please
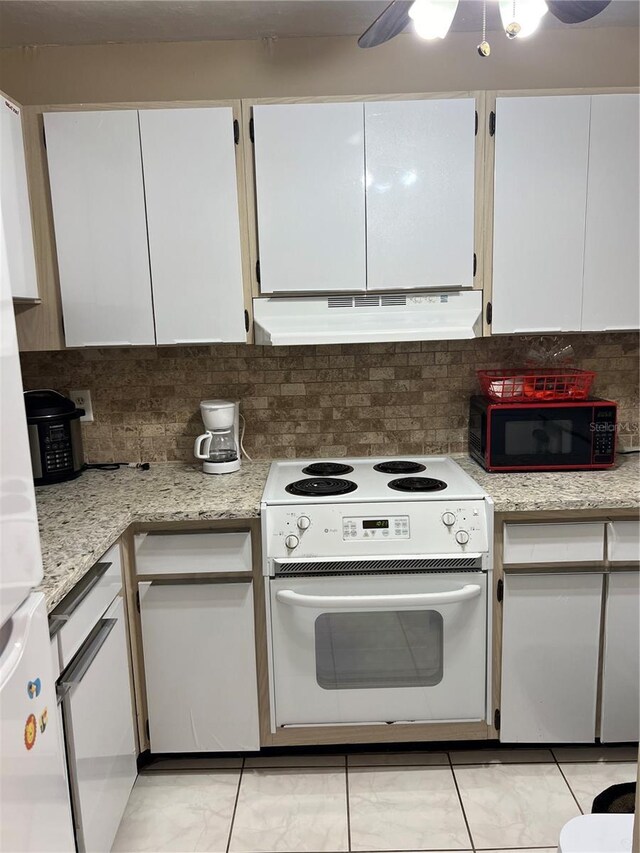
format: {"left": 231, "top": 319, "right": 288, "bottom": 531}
{"left": 276, "top": 583, "right": 482, "bottom": 610}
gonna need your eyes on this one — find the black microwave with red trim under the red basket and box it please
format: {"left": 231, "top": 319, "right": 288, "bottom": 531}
{"left": 469, "top": 396, "right": 617, "bottom": 471}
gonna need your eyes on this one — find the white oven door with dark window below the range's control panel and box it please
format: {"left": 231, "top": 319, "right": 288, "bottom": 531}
{"left": 269, "top": 571, "right": 487, "bottom": 726}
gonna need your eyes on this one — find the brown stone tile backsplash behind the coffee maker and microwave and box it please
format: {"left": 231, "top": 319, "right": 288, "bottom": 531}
{"left": 22, "top": 333, "right": 639, "bottom": 462}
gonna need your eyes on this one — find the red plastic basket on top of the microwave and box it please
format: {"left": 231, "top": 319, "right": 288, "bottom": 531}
{"left": 478, "top": 367, "right": 596, "bottom": 403}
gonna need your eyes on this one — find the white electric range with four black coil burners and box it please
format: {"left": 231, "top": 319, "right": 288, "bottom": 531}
{"left": 262, "top": 456, "right": 493, "bottom": 731}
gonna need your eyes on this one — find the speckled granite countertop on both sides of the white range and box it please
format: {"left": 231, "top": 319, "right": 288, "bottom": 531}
{"left": 36, "top": 455, "right": 640, "bottom": 611}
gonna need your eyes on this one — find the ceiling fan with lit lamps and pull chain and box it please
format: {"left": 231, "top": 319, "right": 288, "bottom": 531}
{"left": 358, "top": 0, "right": 611, "bottom": 56}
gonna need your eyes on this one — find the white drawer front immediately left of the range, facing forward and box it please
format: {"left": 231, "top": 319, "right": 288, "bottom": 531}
{"left": 135, "top": 530, "right": 251, "bottom": 575}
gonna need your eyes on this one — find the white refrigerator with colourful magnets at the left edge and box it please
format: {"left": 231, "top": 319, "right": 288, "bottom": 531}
{"left": 0, "top": 198, "right": 75, "bottom": 853}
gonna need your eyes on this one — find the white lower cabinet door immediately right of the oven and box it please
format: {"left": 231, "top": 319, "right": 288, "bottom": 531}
{"left": 500, "top": 573, "right": 602, "bottom": 743}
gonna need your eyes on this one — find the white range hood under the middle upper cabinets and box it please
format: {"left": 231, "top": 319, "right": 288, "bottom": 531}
{"left": 253, "top": 290, "right": 482, "bottom": 346}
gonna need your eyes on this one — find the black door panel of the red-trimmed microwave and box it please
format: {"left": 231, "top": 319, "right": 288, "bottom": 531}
{"left": 491, "top": 406, "right": 593, "bottom": 466}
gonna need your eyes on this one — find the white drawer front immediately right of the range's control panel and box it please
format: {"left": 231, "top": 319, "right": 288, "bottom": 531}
{"left": 504, "top": 521, "right": 604, "bottom": 564}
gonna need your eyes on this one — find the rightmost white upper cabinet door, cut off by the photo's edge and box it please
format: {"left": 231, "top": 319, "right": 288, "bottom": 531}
{"left": 582, "top": 95, "right": 640, "bottom": 332}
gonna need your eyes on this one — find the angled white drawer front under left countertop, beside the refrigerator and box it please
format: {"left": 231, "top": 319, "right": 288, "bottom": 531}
{"left": 51, "top": 543, "right": 122, "bottom": 669}
